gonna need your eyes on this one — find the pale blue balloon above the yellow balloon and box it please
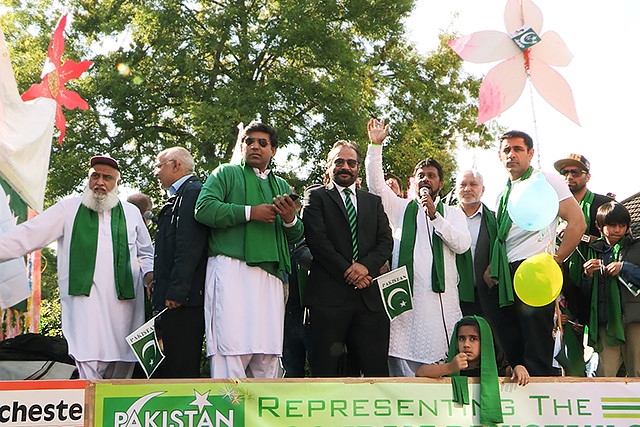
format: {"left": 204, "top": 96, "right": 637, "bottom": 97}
{"left": 507, "top": 173, "right": 560, "bottom": 231}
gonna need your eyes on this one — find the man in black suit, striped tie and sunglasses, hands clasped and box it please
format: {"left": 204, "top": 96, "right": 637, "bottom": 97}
{"left": 303, "top": 141, "right": 393, "bottom": 377}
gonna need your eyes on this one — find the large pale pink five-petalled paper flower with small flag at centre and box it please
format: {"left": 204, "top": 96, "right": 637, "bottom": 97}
{"left": 449, "top": 0, "right": 580, "bottom": 125}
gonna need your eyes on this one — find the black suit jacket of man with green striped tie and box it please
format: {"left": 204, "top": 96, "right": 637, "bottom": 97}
{"left": 302, "top": 183, "right": 393, "bottom": 311}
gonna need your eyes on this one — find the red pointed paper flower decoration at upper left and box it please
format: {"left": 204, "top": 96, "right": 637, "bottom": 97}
{"left": 22, "top": 15, "right": 93, "bottom": 145}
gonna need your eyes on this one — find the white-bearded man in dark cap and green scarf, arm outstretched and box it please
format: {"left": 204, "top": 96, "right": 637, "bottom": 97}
{"left": 0, "top": 156, "right": 153, "bottom": 380}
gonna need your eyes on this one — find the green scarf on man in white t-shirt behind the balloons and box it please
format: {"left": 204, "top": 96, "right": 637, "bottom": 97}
{"left": 491, "top": 166, "right": 533, "bottom": 307}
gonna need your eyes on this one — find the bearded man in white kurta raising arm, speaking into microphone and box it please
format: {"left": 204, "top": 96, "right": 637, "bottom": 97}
{"left": 365, "top": 119, "right": 471, "bottom": 377}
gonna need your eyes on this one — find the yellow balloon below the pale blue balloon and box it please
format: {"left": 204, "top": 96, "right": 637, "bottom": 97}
{"left": 513, "top": 252, "right": 562, "bottom": 307}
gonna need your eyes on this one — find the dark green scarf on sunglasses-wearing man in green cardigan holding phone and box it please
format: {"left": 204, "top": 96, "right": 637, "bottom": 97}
{"left": 241, "top": 165, "right": 291, "bottom": 278}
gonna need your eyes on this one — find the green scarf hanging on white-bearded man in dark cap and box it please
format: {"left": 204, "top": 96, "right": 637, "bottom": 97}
{"left": 69, "top": 202, "right": 135, "bottom": 300}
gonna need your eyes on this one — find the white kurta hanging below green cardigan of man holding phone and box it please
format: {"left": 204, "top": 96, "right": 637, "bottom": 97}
{"left": 204, "top": 255, "right": 284, "bottom": 378}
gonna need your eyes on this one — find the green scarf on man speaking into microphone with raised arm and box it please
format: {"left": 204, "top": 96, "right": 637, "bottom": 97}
{"left": 398, "top": 199, "right": 445, "bottom": 293}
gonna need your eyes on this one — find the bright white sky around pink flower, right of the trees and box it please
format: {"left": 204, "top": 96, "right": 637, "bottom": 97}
{"left": 404, "top": 0, "right": 640, "bottom": 206}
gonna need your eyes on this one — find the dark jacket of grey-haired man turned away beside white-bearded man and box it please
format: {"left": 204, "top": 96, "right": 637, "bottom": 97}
{"left": 152, "top": 176, "right": 209, "bottom": 310}
